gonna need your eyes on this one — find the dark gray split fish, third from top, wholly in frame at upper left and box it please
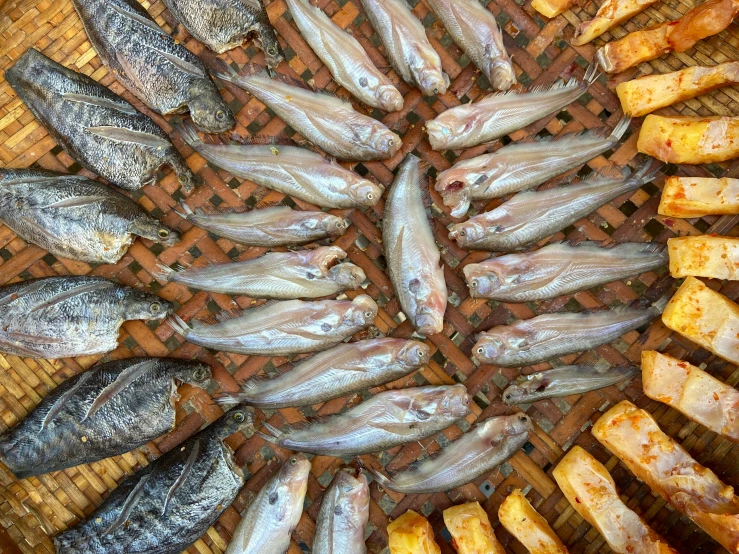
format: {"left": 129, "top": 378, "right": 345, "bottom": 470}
{"left": 5, "top": 48, "right": 193, "bottom": 192}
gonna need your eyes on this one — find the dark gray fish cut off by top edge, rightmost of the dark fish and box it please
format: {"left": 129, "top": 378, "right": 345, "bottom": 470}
{"left": 164, "top": 0, "right": 285, "bottom": 63}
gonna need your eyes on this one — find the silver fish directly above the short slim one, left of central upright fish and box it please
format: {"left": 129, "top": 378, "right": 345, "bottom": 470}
{"left": 180, "top": 127, "right": 383, "bottom": 208}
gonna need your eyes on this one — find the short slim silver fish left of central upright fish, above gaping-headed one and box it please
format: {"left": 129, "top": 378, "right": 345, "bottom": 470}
{"left": 178, "top": 202, "right": 347, "bottom": 246}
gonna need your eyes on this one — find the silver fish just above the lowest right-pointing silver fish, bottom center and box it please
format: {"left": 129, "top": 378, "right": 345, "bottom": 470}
{"left": 261, "top": 385, "right": 470, "bottom": 454}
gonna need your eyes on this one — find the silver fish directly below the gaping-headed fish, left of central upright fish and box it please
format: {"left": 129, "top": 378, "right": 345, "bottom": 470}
{"left": 167, "top": 294, "right": 377, "bottom": 356}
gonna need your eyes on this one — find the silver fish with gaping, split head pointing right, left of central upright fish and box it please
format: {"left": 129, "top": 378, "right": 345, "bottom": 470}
{"left": 155, "top": 246, "right": 367, "bottom": 300}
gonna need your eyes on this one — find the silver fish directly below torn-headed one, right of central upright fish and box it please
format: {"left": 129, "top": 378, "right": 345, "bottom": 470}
{"left": 449, "top": 160, "right": 660, "bottom": 252}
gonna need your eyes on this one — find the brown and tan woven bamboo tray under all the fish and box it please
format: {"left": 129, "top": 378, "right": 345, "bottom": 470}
{"left": 0, "top": 0, "right": 739, "bottom": 554}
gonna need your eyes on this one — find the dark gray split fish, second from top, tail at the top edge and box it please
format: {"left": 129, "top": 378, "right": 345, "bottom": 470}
{"left": 72, "top": 0, "right": 236, "bottom": 133}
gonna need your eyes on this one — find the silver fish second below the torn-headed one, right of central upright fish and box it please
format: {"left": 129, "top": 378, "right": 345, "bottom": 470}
{"left": 463, "top": 241, "right": 668, "bottom": 302}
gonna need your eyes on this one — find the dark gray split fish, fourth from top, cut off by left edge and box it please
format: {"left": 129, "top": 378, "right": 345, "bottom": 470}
{"left": 0, "top": 169, "right": 180, "bottom": 264}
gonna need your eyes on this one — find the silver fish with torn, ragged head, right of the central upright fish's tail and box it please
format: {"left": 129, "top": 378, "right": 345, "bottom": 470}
{"left": 434, "top": 118, "right": 631, "bottom": 217}
